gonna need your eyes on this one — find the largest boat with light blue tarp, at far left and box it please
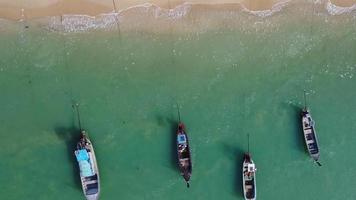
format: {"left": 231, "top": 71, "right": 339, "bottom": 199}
{"left": 74, "top": 105, "right": 100, "bottom": 200}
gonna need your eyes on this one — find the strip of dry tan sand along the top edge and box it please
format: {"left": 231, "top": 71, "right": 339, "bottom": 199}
{"left": 0, "top": 0, "right": 356, "bottom": 20}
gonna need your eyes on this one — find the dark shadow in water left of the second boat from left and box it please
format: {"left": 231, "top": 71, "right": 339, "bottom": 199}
{"left": 157, "top": 116, "right": 180, "bottom": 174}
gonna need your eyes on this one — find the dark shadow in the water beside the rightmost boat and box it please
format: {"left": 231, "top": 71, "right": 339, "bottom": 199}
{"left": 289, "top": 105, "right": 308, "bottom": 154}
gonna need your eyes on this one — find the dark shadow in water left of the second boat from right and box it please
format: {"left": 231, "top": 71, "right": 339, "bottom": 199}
{"left": 223, "top": 144, "right": 245, "bottom": 197}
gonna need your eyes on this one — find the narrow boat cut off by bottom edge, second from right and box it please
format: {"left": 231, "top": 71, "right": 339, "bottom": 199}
{"left": 242, "top": 142, "right": 257, "bottom": 200}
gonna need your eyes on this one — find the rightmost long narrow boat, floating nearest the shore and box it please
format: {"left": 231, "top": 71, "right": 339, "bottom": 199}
{"left": 302, "top": 93, "right": 321, "bottom": 166}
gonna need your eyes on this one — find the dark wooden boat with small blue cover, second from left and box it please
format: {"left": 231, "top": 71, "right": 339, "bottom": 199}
{"left": 177, "top": 122, "right": 192, "bottom": 188}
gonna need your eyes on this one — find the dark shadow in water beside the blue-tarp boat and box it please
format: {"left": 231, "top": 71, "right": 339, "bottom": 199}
{"left": 54, "top": 126, "right": 82, "bottom": 190}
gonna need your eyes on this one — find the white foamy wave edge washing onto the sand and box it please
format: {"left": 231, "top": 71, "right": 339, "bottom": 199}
{"left": 0, "top": 0, "right": 356, "bottom": 32}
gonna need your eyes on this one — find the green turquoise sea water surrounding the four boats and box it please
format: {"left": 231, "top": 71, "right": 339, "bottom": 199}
{"left": 0, "top": 3, "right": 356, "bottom": 200}
